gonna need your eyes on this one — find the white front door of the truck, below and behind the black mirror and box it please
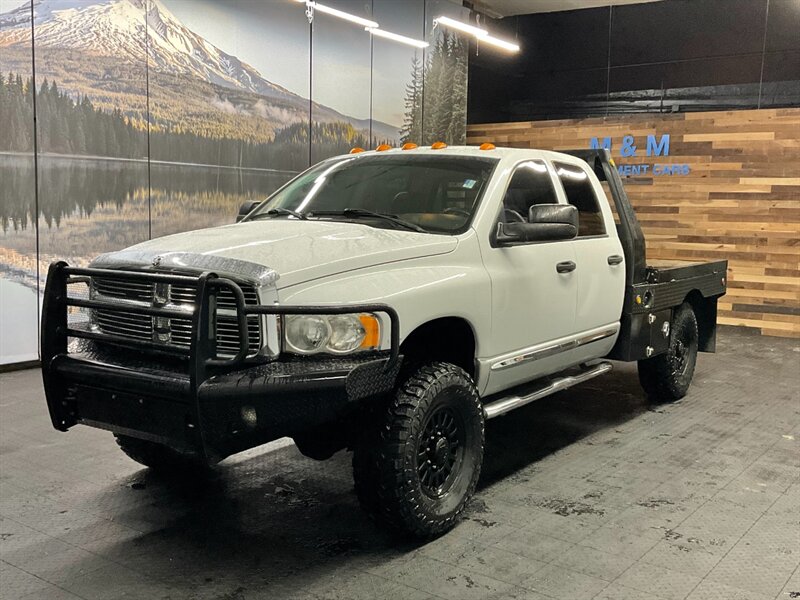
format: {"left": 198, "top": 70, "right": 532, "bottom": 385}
{"left": 483, "top": 160, "right": 578, "bottom": 394}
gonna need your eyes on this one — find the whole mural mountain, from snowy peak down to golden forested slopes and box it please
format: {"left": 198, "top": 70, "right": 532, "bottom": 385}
{"left": 0, "top": 0, "right": 400, "bottom": 148}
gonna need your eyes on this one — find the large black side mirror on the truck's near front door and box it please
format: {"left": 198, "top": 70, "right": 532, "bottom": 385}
{"left": 497, "top": 204, "right": 578, "bottom": 246}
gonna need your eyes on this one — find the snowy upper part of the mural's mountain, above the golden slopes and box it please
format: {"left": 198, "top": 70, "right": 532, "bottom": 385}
{"left": 0, "top": 0, "right": 397, "bottom": 137}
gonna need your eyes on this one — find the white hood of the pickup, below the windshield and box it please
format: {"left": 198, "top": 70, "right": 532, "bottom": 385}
{"left": 101, "top": 218, "right": 458, "bottom": 289}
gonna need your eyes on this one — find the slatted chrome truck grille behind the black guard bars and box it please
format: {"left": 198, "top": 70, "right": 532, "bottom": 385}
{"left": 92, "top": 277, "right": 262, "bottom": 357}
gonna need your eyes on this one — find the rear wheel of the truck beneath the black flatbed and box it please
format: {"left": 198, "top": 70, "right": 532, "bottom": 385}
{"left": 639, "top": 302, "right": 699, "bottom": 402}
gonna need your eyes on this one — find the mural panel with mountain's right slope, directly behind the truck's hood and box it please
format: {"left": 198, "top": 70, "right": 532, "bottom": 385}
{"left": 147, "top": 0, "right": 309, "bottom": 237}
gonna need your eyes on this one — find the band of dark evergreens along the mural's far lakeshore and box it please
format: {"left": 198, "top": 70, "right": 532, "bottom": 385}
{"left": 0, "top": 73, "right": 382, "bottom": 171}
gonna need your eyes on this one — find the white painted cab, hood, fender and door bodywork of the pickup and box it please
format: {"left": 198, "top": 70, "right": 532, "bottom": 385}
{"left": 115, "top": 147, "right": 625, "bottom": 395}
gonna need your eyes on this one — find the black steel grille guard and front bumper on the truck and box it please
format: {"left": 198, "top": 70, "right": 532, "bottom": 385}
{"left": 41, "top": 262, "right": 402, "bottom": 461}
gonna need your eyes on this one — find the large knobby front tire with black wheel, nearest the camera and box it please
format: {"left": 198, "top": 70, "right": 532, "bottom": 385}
{"left": 353, "top": 362, "right": 484, "bottom": 537}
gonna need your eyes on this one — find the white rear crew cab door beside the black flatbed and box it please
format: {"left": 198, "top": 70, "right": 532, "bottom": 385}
{"left": 553, "top": 161, "right": 625, "bottom": 342}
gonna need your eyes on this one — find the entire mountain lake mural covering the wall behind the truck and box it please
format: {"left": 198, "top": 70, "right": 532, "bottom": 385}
{"left": 0, "top": 0, "right": 466, "bottom": 363}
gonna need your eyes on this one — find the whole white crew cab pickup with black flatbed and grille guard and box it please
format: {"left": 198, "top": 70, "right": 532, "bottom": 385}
{"left": 42, "top": 144, "right": 727, "bottom": 536}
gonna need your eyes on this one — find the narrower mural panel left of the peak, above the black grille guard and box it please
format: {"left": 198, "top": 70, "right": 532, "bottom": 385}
{"left": 28, "top": 0, "right": 149, "bottom": 283}
